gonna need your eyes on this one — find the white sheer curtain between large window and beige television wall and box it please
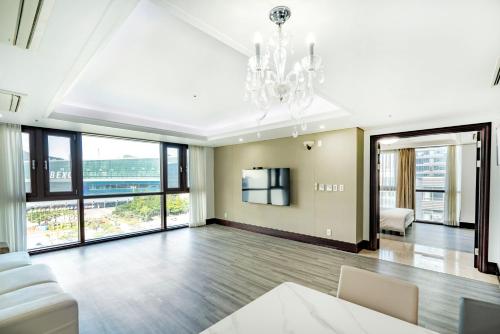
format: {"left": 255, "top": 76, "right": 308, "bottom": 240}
{"left": 189, "top": 146, "right": 207, "bottom": 227}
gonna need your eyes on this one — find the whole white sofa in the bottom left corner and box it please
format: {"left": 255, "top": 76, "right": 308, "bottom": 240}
{"left": 0, "top": 252, "right": 78, "bottom": 334}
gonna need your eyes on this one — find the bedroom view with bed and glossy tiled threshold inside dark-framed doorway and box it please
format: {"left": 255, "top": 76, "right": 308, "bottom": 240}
{"left": 360, "top": 124, "right": 496, "bottom": 283}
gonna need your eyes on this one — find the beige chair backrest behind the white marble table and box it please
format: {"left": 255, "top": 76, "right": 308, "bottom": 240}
{"left": 337, "top": 266, "right": 418, "bottom": 324}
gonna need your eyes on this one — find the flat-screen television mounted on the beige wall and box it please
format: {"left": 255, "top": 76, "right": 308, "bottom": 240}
{"left": 241, "top": 168, "right": 290, "bottom": 206}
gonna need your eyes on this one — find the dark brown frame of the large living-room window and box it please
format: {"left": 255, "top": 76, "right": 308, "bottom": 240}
{"left": 22, "top": 126, "right": 189, "bottom": 254}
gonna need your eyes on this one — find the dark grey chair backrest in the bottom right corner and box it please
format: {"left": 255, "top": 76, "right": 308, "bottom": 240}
{"left": 458, "top": 298, "right": 500, "bottom": 334}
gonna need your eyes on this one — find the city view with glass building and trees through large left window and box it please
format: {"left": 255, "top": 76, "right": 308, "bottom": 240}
{"left": 23, "top": 136, "right": 189, "bottom": 249}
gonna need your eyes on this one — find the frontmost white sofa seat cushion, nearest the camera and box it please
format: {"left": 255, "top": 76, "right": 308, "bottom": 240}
{"left": 0, "top": 282, "right": 63, "bottom": 310}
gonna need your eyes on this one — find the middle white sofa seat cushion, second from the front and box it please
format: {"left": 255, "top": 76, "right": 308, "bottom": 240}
{"left": 0, "top": 264, "right": 57, "bottom": 294}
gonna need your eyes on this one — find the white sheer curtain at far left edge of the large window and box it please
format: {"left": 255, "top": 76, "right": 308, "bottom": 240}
{"left": 0, "top": 124, "right": 27, "bottom": 251}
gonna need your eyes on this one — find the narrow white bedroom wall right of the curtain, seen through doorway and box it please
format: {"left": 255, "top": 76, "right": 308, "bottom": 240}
{"left": 460, "top": 144, "right": 476, "bottom": 223}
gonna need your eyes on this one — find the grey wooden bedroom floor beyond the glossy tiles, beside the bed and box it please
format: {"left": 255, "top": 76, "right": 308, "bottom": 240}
{"left": 380, "top": 222, "right": 474, "bottom": 253}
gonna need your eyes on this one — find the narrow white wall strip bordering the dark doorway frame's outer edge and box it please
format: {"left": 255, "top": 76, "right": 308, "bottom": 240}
{"left": 363, "top": 115, "right": 500, "bottom": 264}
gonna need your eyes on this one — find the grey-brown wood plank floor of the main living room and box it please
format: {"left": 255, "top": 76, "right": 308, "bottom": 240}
{"left": 33, "top": 225, "right": 500, "bottom": 334}
